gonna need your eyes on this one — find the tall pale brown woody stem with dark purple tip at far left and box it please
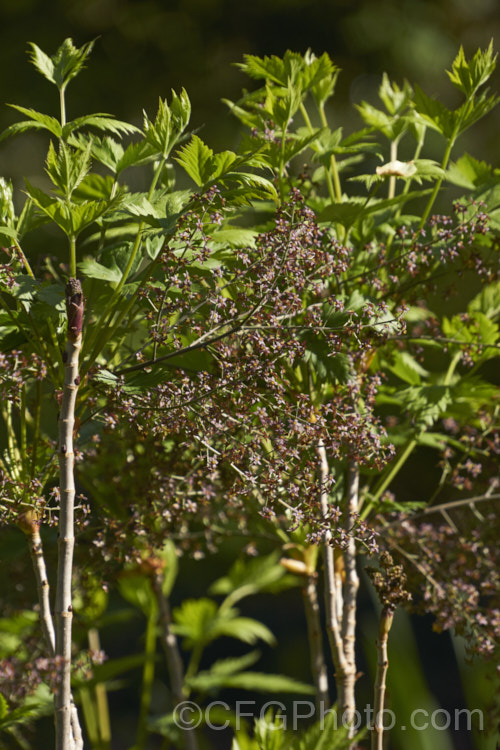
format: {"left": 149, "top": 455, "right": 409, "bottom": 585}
{"left": 55, "top": 278, "right": 84, "bottom": 750}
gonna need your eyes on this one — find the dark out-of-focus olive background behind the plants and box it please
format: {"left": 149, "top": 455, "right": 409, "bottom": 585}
{"left": 0, "top": 0, "right": 500, "bottom": 750}
